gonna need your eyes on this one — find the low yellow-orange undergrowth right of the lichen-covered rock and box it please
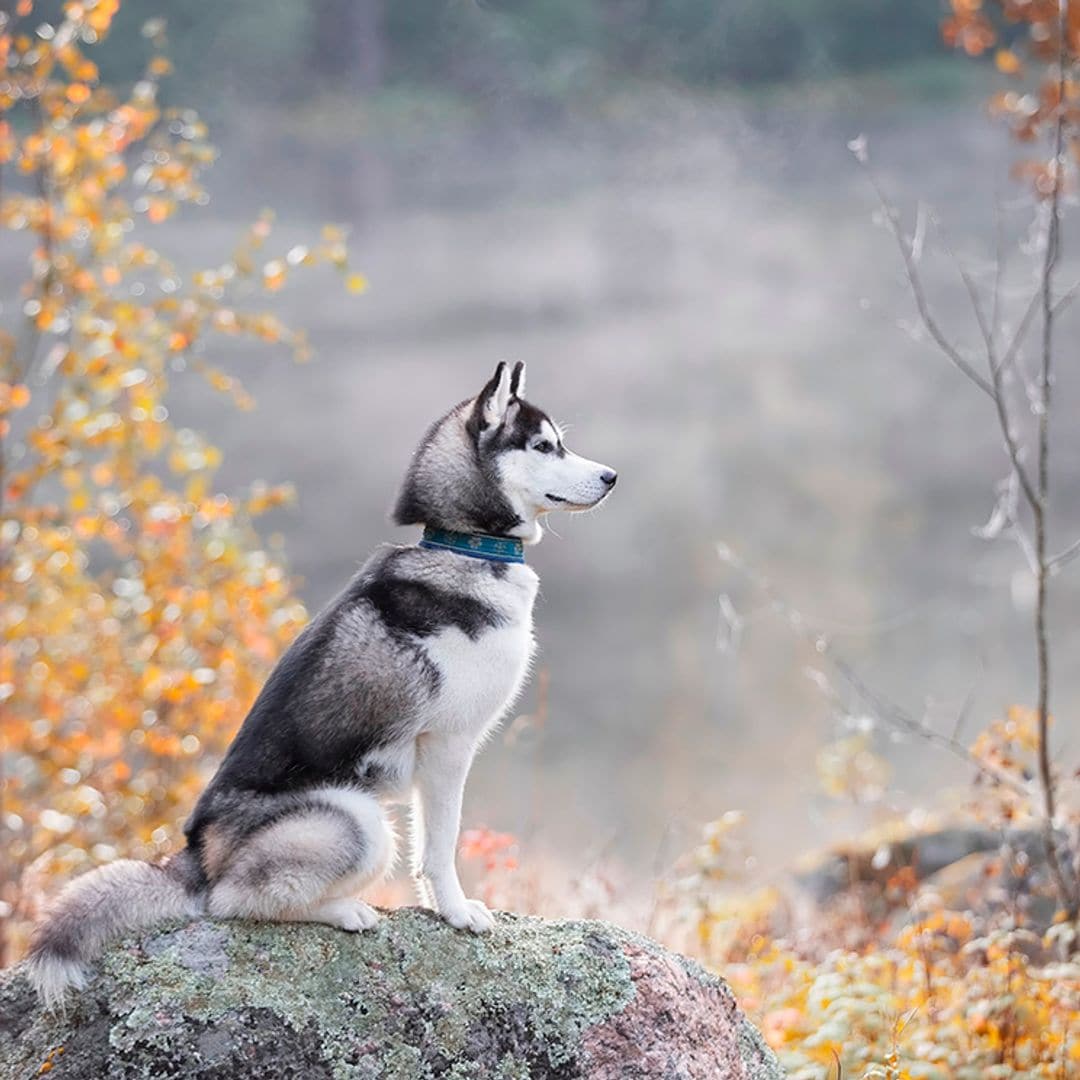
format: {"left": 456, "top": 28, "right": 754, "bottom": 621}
{"left": 661, "top": 814, "right": 1080, "bottom": 1080}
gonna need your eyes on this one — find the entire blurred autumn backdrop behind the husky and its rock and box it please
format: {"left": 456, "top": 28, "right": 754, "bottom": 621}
{"left": 6, "top": 6, "right": 1080, "bottom": 1080}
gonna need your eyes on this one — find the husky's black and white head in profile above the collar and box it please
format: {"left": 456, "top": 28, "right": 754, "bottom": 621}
{"left": 393, "top": 363, "right": 616, "bottom": 543}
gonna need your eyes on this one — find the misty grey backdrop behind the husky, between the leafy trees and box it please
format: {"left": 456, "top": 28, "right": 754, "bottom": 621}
{"left": 25, "top": 0, "right": 1080, "bottom": 885}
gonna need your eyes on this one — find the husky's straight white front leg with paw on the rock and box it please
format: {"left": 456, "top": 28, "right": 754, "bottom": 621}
{"left": 413, "top": 733, "right": 495, "bottom": 933}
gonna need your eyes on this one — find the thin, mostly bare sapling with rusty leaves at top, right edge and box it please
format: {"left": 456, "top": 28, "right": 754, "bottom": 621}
{"left": 876, "top": 0, "right": 1080, "bottom": 922}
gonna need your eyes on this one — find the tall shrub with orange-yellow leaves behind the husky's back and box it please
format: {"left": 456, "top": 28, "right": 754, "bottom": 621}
{"left": 0, "top": 0, "right": 363, "bottom": 962}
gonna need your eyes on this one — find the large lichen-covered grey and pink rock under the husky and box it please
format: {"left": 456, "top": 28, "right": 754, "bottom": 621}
{"left": 0, "top": 909, "right": 783, "bottom": 1080}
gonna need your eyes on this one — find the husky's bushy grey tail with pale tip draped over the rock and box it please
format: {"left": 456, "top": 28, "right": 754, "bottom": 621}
{"left": 26, "top": 850, "right": 203, "bottom": 1009}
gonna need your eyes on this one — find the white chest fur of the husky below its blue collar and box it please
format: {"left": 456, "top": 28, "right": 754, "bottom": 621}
{"left": 424, "top": 571, "right": 536, "bottom": 734}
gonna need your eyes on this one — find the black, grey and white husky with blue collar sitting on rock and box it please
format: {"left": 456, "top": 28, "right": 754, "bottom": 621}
{"left": 28, "top": 363, "right": 616, "bottom": 1005}
